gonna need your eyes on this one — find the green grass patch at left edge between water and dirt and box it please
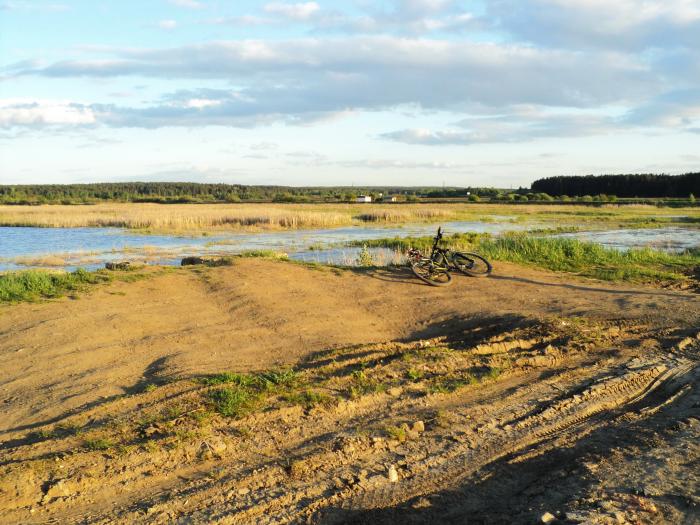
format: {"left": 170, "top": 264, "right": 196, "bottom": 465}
{"left": 0, "top": 268, "right": 110, "bottom": 303}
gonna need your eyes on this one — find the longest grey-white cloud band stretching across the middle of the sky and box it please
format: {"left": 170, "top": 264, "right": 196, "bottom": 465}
{"left": 21, "top": 36, "right": 661, "bottom": 111}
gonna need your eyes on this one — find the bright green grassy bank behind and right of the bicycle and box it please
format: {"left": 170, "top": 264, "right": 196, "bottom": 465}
{"left": 358, "top": 233, "right": 700, "bottom": 284}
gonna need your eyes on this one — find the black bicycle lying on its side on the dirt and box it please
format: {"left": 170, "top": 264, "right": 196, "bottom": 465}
{"left": 407, "top": 227, "right": 493, "bottom": 286}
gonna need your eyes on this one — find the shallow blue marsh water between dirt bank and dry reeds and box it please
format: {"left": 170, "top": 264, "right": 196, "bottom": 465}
{"left": 0, "top": 218, "right": 700, "bottom": 271}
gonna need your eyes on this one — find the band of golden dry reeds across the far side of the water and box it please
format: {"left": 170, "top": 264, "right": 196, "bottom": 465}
{"left": 0, "top": 203, "right": 699, "bottom": 232}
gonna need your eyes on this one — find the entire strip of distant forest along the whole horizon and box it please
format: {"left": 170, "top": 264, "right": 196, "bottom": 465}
{"left": 0, "top": 173, "right": 700, "bottom": 204}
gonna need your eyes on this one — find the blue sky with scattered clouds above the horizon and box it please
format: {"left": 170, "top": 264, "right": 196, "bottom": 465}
{"left": 0, "top": 0, "right": 700, "bottom": 188}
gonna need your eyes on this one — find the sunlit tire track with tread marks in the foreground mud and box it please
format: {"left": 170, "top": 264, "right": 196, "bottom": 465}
{"left": 313, "top": 344, "right": 698, "bottom": 523}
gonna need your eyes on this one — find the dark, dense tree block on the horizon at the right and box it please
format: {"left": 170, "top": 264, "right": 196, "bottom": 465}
{"left": 532, "top": 173, "right": 700, "bottom": 198}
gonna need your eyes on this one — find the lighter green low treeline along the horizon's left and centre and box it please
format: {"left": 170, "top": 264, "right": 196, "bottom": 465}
{"left": 0, "top": 182, "right": 448, "bottom": 204}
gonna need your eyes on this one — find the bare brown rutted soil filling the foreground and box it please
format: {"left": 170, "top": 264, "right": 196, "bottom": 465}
{"left": 0, "top": 259, "right": 700, "bottom": 523}
